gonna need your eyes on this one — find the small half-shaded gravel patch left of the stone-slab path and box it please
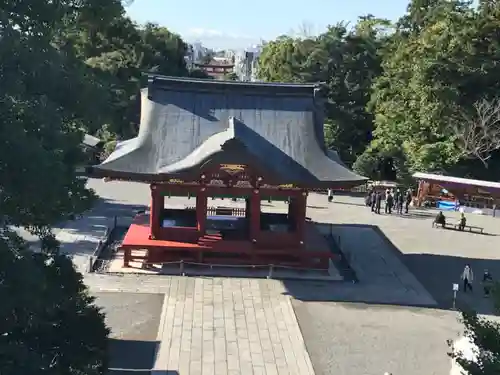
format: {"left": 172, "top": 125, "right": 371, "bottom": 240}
{"left": 94, "top": 292, "right": 164, "bottom": 375}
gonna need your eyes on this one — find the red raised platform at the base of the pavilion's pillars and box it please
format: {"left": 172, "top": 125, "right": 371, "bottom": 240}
{"left": 121, "top": 215, "right": 334, "bottom": 269}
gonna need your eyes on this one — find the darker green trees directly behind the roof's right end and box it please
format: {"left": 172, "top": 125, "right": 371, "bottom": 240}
{"left": 258, "top": 16, "right": 389, "bottom": 164}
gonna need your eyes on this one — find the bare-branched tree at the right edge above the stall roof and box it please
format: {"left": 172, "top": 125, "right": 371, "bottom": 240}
{"left": 453, "top": 99, "right": 500, "bottom": 168}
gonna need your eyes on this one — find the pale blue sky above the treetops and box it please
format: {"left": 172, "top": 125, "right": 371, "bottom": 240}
{"left": 126, "top": 0, "right": 408, "bottom": 49}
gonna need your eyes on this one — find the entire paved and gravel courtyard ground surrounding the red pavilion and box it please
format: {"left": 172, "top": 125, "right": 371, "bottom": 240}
{"left": 49, "top": 180, "right": 500, "bottom": 375}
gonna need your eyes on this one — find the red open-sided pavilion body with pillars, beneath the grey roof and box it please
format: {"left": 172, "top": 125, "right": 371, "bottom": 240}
{"left": 117, "top": 164, "right": 331, "bottom": 268}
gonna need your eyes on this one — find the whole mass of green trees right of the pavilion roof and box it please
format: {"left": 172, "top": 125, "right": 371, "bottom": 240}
{"left": 259, "top": 0, "right": 500, "bottom": 179}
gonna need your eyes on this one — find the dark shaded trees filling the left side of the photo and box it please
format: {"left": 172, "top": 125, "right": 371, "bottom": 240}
{"left": 0, "top": 0, "right": 193, "bottom": 375}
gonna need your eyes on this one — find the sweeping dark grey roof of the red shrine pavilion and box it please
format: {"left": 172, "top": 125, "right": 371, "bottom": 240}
{"left": 94, "top": 76, "right": 365, "bottom": 188}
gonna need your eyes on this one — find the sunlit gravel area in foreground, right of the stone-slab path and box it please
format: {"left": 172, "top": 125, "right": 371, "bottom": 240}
{"left": 293, "top": 301, "right": 461, "bottom": 375}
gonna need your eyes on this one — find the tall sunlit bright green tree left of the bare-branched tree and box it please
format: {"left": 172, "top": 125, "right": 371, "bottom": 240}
{"left": 370, "top": 1, "right": 474, "bottom": 175}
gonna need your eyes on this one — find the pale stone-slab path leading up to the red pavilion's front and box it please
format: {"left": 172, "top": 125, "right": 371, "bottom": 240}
{"left": 85, "top": 274, "right": 314, "bottom": 375}
